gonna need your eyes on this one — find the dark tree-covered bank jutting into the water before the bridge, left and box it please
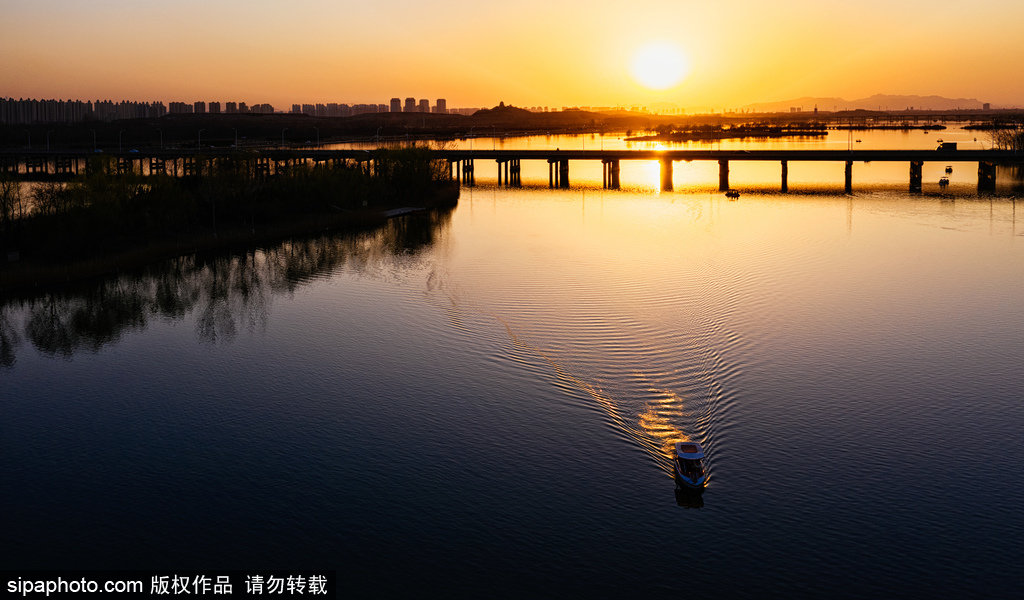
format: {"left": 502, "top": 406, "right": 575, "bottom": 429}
{"left": 0, "top": 142, "right": 459, "bottom": 288}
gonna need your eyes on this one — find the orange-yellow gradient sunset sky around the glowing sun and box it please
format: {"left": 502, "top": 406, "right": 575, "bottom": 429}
{"left": 0, "top": 0, "right": 1024, "bottom": 110}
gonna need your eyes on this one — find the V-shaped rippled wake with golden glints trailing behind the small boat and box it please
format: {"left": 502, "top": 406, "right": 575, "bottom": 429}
{"left": 419, "top": 258, "right": 742, "bottom": 479}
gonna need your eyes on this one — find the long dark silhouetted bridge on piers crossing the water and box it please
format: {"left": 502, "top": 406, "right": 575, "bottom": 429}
{"left": 0, "top": 148, "right": 1024, "bottom": 192}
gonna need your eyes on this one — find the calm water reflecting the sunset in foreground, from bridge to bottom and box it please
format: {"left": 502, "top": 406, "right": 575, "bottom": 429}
{"left": 0, "top": 133, "right": 1024, "bottom": 598}
